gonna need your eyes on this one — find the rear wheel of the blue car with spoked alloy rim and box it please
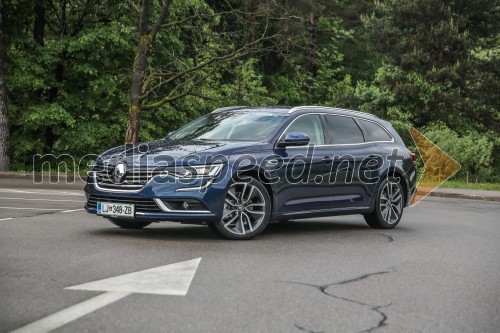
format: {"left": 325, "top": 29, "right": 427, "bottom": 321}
{"left": 364, "top": 178, "right": 404, "bottom": 229}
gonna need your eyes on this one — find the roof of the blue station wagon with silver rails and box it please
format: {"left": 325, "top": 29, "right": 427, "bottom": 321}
{"left": 212, "top": 106, "right": 379, "bottom": 119}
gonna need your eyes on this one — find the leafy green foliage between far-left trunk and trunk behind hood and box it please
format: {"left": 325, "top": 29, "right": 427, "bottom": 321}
{"left": 3, "top": 0, "right": 134, "bottom": 169}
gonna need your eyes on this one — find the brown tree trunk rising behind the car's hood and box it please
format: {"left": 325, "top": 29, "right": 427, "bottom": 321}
{"left": 125, "top": 0, "right": 153, "bottom": 144}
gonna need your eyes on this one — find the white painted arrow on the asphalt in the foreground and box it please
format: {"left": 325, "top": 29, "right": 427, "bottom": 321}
{"left": 11, "top": 258, "right": 201, "bottom": 333}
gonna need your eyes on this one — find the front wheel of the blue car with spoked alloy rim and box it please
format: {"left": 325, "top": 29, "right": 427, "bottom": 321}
{"left": 209, "top": 177, "right": 271, "bottom": 240}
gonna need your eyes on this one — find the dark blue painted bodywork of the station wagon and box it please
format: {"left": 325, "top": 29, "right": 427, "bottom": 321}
{"left": 85, "top": 109, "right": 416, "bottom": 223}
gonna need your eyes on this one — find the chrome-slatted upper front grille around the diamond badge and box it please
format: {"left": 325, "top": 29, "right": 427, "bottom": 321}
{"left": 93, "top": 165, "right": 162, "bottom": 190}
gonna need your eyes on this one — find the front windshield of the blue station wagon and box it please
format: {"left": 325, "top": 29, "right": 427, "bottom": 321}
{"left": 168, "top": 111, "right": 287, "bottom": 141}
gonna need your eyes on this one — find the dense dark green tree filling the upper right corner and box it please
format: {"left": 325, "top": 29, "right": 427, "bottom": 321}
{"left": 364, "top": 0, "right": 500, "bottom": 130}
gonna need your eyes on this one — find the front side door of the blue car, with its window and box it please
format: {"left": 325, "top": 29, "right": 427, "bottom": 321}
{"left": 274, "top": 114, "right": 330, "bottom": 213}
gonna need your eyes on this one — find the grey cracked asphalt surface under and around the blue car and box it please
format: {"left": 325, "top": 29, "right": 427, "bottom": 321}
{"left": 0, "top": 182, "right": 500, "bottom": 333}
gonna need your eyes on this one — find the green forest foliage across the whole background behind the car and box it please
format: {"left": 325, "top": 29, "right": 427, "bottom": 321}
{"left": 2, "top": 0, "right": 500, "bottom": 181}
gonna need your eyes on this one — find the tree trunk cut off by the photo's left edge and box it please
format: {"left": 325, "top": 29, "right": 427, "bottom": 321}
{"left": 0, "top": 0, "right": 9, "bottom": 171}
